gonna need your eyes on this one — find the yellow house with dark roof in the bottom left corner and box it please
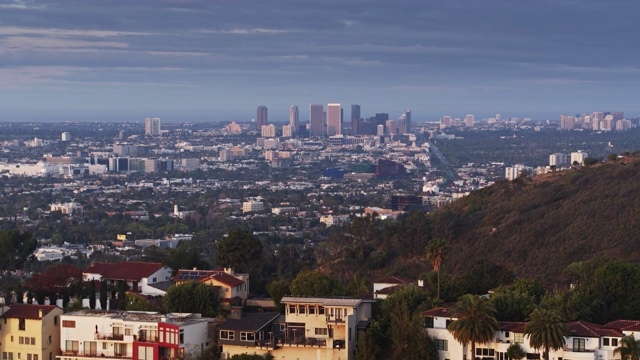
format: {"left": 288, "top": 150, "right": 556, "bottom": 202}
{"left": 0, "top": 304, "right": 63, "bottom": 360}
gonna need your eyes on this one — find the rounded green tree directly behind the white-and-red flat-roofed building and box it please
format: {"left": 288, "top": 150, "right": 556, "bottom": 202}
{"left": 162, "top": 281, "right": 220, "bottom": 317}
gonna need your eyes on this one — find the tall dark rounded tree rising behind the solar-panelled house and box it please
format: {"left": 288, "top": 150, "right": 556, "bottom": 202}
{"left": 216, "top": 229, "right": 263, "bottom": 272}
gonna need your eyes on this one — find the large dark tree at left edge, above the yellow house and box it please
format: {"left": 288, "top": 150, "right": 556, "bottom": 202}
{"left": 0, "top": 230, "right": 38, "bottom": 271}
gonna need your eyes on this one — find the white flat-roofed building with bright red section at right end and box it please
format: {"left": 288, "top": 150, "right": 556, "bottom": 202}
{"left": 57, "top": 310, "right": 213, "bottom": 360}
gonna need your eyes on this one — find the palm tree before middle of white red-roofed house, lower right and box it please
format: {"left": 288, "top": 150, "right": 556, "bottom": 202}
{"left": 524, "top": 308, "right": 569, "bottom": 360}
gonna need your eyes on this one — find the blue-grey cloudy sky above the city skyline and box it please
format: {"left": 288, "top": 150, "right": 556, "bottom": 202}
{"left": 0, "top": 0, "right": 640, "bottom": 122}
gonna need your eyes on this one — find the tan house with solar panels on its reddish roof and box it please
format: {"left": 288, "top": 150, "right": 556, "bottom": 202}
{"left": 175, "top": 268, "right": 249, "bottom": 304}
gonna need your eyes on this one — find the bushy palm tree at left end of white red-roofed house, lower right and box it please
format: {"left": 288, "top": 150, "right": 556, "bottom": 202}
{"left": 447, "top": 294, "right": 498, "bottom": 359}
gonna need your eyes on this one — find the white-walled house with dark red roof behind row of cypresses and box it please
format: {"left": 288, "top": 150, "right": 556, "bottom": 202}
{"left": 82, "top": 261, "right": 171, "bottom": 295}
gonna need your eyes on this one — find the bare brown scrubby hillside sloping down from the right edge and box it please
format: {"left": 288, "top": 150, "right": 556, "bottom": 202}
{"left": 436, "top": 157, "right": 640, "bottom": 282}
